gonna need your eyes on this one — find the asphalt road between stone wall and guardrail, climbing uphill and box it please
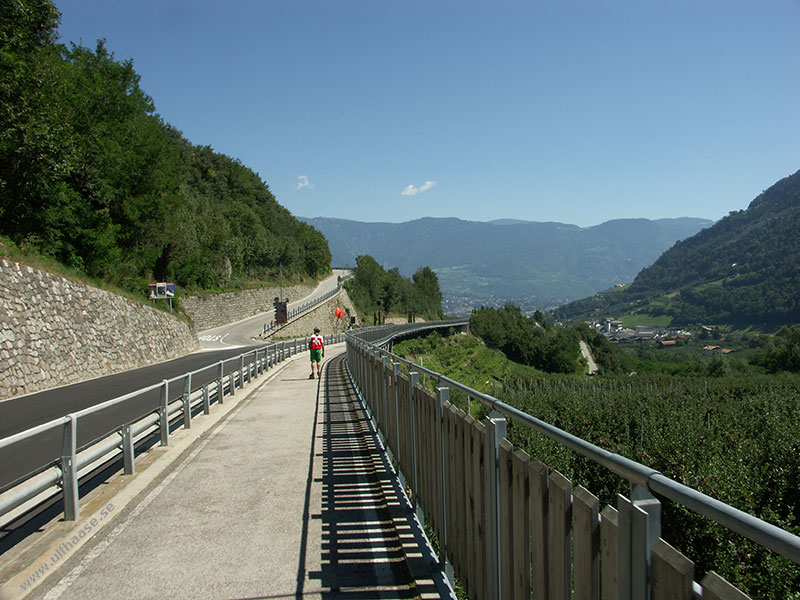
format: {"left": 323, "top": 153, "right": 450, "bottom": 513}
{"left": 0, "top": 271, "right": 350, "bottom": 492}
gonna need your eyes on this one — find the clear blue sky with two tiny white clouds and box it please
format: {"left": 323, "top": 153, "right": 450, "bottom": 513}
{"left": 55, "top": 0, "right": 800, "bottom": 226}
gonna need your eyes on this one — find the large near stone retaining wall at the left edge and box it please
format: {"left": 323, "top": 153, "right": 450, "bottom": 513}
{"left": 0, "top": 259, "right": 197, "bottom": 398}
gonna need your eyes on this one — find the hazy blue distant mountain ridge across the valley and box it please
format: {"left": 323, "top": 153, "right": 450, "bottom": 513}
{"left": 298, "top": 217, "right": 712, "bottom": 313}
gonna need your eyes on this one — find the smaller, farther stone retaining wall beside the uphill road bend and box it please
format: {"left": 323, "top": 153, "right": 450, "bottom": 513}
{"left": 181, "top": 285, "right": 314, "bottom": 331}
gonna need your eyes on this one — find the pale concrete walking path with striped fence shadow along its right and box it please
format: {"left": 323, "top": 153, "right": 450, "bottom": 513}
{"left": 20, "top": 345, "right": 440, "bottom": 600}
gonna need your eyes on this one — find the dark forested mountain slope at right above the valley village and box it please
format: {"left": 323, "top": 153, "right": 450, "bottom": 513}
{"left": 556, "top": 171, "right": 800, "bottom": 327}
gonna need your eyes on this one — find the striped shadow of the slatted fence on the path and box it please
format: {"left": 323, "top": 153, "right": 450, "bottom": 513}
{"left": 298, "top": 357, "right": 439, "bottom": 600}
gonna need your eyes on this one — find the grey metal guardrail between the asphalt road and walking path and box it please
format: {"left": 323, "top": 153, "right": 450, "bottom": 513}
{"left": 0, "top": 334, "right": 344, "bottom": 520}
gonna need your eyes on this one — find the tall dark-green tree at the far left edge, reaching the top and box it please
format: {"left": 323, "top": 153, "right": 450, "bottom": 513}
{"left": 0, "top": 0, "right": 75, "bottom": 246}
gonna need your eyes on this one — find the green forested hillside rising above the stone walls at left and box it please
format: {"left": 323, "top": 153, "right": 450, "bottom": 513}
{"left": 0, "top": 0, "right": 330, "bottom": 293}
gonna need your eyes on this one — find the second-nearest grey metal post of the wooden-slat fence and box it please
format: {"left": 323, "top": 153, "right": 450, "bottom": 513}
{"left": 486, "top": 415, "right": 506, "bottom": 600}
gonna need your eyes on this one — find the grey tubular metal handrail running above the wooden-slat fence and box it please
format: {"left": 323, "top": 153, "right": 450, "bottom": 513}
{"left": 346, "top": 321, "right": 800, "bottom": 597}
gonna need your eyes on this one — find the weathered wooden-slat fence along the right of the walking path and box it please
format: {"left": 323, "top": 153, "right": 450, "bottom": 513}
{"left": 348, "top": 344, "right": 747, "bottom": 600}
